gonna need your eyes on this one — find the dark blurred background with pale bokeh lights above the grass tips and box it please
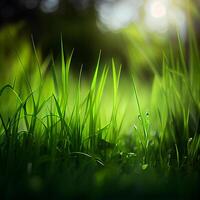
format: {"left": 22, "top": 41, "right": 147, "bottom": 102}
{"left": 0, "top": 0, "right": 200, "bottom": 80}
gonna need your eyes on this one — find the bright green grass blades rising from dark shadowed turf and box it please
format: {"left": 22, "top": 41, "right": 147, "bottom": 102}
{"left": 0, "top": 32, "right": 200, "bottom": 199}
